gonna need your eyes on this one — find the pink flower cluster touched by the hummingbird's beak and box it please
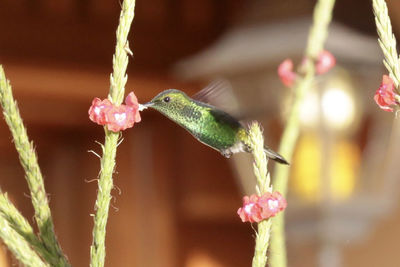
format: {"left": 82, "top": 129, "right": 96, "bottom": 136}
{"left": 89, "top": 92, "right": 141, "bottom": 132}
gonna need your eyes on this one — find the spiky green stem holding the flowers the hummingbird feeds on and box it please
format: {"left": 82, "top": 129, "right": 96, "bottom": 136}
{"left": 90, "top": 0, "right": 135, "bottom": 267}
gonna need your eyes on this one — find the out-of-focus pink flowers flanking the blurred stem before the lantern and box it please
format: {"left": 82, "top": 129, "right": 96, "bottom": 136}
{"left": 278, "top": 50, "right": 336, "bottom": 87}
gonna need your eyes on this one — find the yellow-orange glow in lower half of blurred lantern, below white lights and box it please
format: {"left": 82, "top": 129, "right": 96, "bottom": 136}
{"left": 290, "top": 133, "right": 361, "bottom": 202}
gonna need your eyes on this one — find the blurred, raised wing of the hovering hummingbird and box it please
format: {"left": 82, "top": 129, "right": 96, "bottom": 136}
{"left": 192, "top": 79, "right": 240, "bottom": 117}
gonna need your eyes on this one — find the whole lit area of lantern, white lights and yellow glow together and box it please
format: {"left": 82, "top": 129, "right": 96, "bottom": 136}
{"left": 290, "top": 72, "right": 360, "bottom": 202}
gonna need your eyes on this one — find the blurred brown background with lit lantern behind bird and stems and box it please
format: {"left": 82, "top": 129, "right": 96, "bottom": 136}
{"left": 0, "top": 0, "right": 400, "bottom": 267}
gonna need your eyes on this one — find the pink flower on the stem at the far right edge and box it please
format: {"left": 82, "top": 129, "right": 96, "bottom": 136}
{"left": 374, "top": 75, "right": 398, "bottom": 111}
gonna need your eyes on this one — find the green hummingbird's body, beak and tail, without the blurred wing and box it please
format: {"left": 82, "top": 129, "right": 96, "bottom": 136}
{"left": 143, "top": 89, "right": 289, "bottom": 164}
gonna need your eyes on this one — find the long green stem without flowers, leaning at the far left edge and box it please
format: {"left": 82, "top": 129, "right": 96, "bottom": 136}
{"left": 0, "top": 66, "right": 69, "bottom": 266}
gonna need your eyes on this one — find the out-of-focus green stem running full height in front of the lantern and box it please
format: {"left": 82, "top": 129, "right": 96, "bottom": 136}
{"left": 269, "top": 0, "right": 335, "bottom": 267}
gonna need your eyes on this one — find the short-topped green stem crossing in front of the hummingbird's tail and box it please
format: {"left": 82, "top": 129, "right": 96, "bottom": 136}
{"left": 249, "top": 122, "right": 272, "bottom": 267}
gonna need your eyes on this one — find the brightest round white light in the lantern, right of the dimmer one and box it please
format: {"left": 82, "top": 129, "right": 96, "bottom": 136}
{"left": 321, "top": 88, "right": 355, "bottom": 130}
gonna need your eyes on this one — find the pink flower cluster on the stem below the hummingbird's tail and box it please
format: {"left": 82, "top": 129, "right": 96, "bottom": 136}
{"left": 237, "top": 192, "right": 287, "bottom": 223}
